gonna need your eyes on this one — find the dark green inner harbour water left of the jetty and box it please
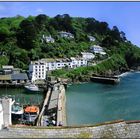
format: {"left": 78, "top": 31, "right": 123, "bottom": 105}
{"left": 0, "top": 88, "right": 43, "bottom": 105}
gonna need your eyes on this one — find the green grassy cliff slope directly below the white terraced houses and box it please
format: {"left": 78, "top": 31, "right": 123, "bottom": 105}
{"left": 52, "top": 54, "right": 128, "bottom": 82}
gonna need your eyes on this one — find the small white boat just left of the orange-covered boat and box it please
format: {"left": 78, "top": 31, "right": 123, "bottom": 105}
{"left": 11, "top": 103, "right": 24, "bottom": 115}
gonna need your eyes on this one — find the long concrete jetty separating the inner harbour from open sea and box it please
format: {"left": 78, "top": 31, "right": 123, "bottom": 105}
{"left": 37, "top": 83, "right": 66, "bottom": 126}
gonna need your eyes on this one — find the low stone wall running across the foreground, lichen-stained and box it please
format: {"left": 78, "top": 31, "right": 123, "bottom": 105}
{"left": 0, "top": 121, "right": 140, "bottom": 139}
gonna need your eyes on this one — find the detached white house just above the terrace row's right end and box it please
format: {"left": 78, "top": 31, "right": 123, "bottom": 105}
{"left": 90, "top": 45, "right": 106, "bottom": 55}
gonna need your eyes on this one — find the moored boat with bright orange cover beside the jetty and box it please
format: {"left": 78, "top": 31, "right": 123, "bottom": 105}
{"left": 23, "top": 105, "right": 39, "bottom": 123}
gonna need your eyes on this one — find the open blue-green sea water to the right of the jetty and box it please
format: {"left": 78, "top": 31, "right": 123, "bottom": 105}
{"left": 66, "top": 73, "right": 140, "bottom": 125}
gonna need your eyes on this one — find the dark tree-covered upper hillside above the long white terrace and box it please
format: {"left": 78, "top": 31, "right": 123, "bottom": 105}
{"left": 0, "top": 14, "right": 140, "bottom": 69}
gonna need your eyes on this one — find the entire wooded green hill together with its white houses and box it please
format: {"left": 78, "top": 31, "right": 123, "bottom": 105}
{"left": 0, "top": 14, "right": 140, "bottom": 82}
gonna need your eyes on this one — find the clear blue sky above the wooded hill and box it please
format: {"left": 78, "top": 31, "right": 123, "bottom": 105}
{"left": 0, "top": 1, "right": 140, "bottom": 47}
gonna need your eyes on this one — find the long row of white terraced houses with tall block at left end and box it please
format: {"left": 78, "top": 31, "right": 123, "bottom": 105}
{"left": 29, "top": 57, "right": 88, "bottom": 82}
